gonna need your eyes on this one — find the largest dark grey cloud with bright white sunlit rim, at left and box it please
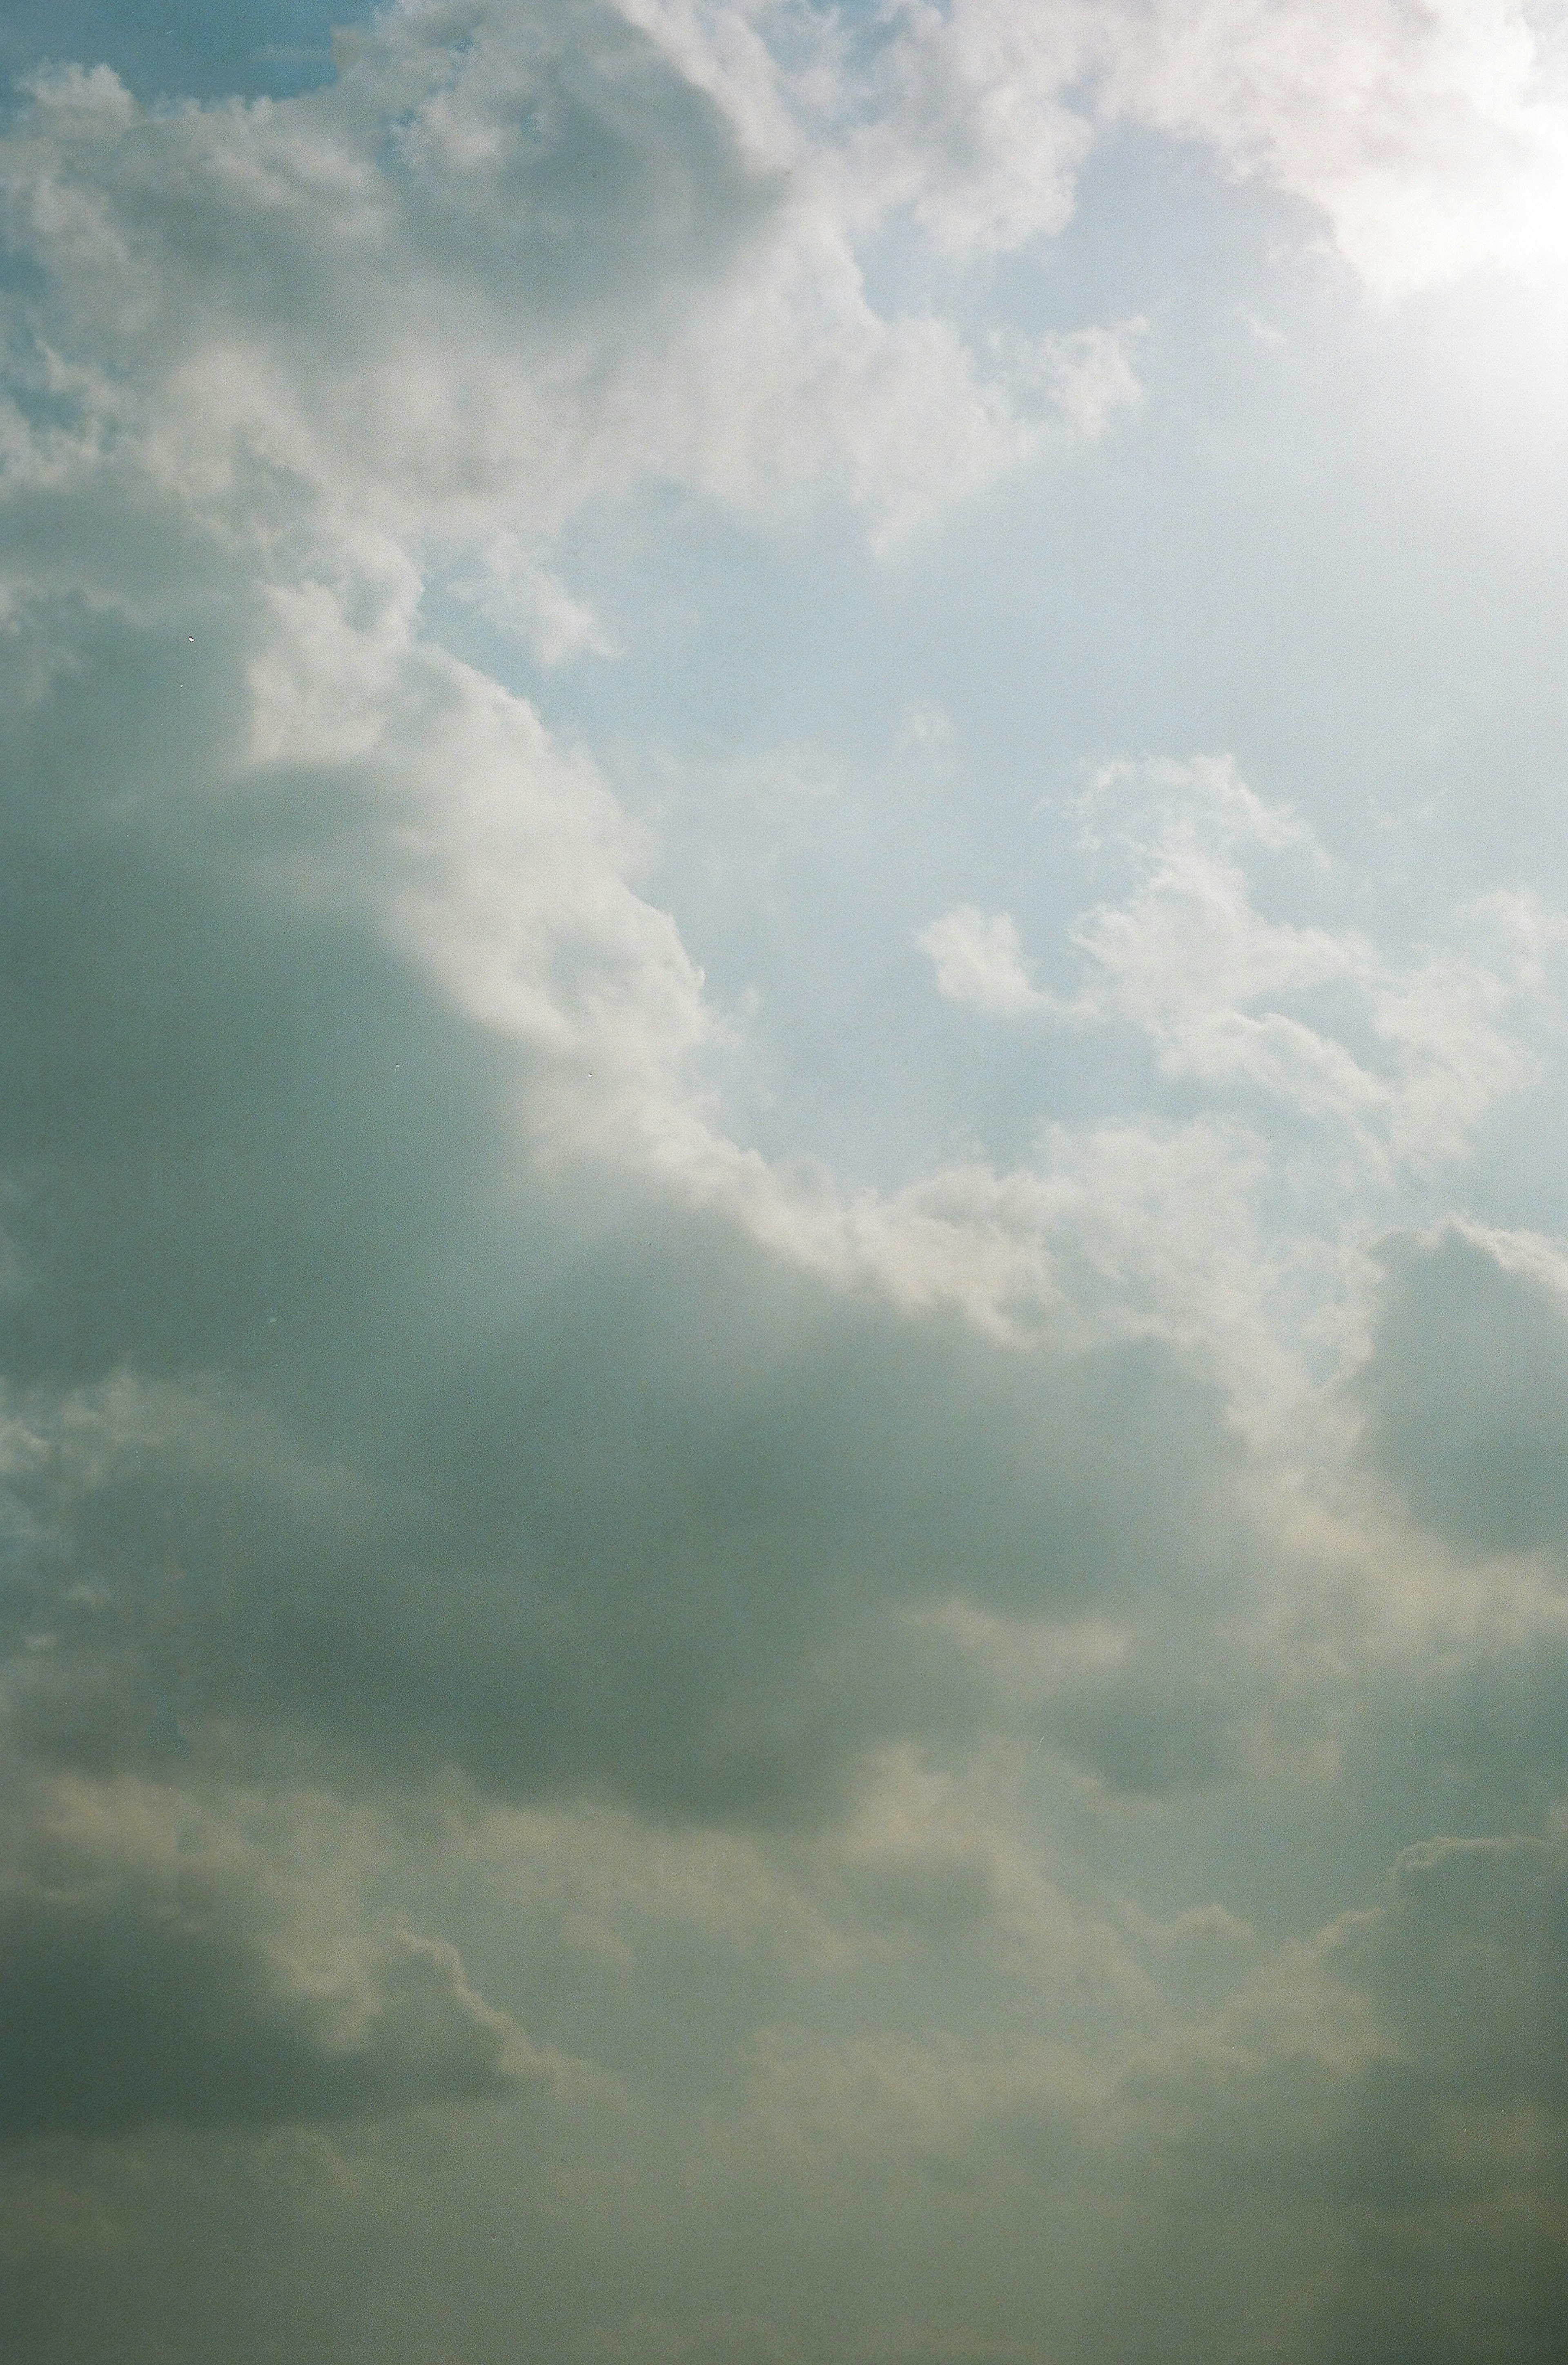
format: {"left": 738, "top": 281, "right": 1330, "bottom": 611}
{"left": 0, "top": 345, "right": 1296, "bottom": 1821}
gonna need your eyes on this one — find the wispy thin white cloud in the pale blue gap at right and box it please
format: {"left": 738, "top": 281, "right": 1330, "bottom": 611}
{"left": 918, "top": 759, "right": 1551, "bottom": 1168}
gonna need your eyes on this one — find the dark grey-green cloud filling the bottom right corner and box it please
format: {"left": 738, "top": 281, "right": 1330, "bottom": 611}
{"left": 1031, "top": 1835, "right": 1568, "bottom": 2365}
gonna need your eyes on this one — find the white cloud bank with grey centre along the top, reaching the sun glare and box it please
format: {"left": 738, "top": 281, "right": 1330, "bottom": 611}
{"left": 37, "top": 0, "right": 1523, "bottom": 584}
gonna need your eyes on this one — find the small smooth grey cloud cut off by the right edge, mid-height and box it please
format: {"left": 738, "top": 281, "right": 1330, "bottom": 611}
{"left": 1358, "top": 1225, "right": 1568, "bottom": 1552}
